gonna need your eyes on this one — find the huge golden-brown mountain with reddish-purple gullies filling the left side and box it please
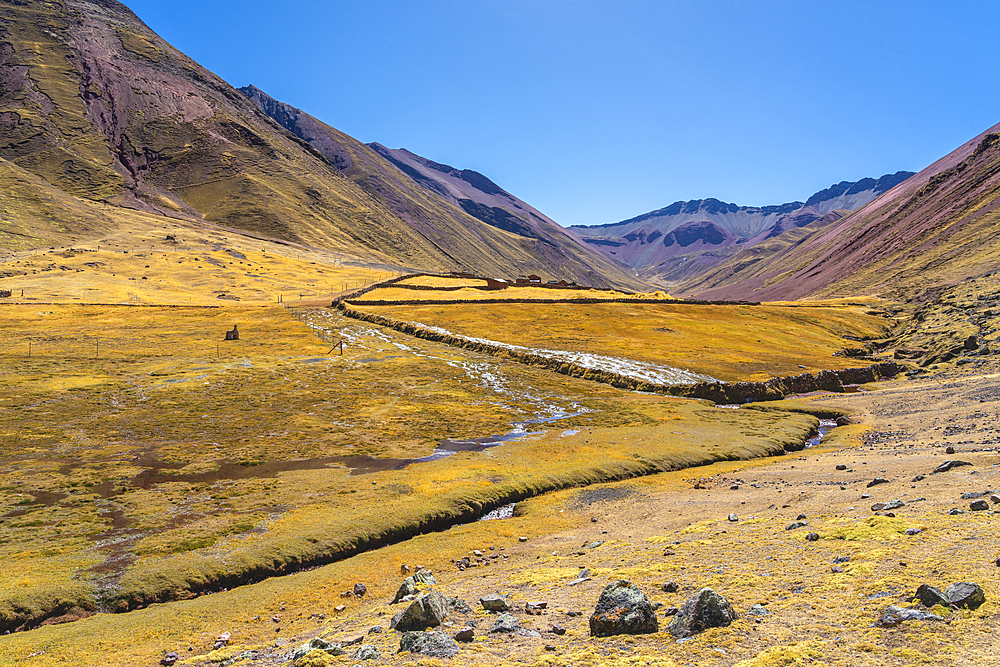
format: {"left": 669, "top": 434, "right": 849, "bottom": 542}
{"left": 0, "top": 0, "right": 640, "bottom": 287}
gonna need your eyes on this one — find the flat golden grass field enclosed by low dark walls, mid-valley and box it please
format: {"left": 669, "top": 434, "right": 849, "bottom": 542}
{"left": 363, "top": 302, "right": 885, "bottom": 381}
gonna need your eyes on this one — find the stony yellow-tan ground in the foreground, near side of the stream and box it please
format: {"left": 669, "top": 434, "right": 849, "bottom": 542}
{"left": 0, "top": 362, "right": 1000, "bottom": 667}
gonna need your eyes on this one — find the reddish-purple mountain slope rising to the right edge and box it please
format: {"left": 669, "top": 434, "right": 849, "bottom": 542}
{"left": 681, "top": 124, "right": 1000, "bottom": 300}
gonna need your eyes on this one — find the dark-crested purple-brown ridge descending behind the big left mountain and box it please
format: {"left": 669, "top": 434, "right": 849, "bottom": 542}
{"left": 240, "top": 86, "right": 643, "bottom": 288}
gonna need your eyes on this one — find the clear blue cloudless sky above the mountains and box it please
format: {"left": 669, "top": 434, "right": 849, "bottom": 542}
{"left": 126, "top": 0, "right": 1000, "bottom": 225}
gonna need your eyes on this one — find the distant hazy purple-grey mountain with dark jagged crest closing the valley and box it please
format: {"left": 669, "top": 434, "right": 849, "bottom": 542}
{"left": 572, "top": 171, "right": 913, "bottom": 284}
